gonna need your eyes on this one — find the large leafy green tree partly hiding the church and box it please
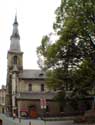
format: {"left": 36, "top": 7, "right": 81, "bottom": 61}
{"left": 37, "top": 0, "right": 95, "bottom": 97}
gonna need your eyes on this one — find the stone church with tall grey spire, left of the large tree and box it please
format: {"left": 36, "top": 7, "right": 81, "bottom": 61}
{"left": 5, "top": 16, "right": 63, "bottom": 118}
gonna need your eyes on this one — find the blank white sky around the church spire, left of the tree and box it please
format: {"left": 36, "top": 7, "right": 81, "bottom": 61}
{"left": 0, "top": 0, "right": 60, "bottom": 87}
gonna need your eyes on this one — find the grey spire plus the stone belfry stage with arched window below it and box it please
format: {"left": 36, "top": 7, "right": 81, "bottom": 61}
{"left": 7, "top": 16, "right": 23, "bottom": 72}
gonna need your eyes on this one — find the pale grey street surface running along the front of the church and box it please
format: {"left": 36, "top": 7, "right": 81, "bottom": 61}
{"left": 0, "top": 114, "right": 86, "bottom": 125}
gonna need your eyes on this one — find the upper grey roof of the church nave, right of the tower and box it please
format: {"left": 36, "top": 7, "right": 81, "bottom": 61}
{"left": 19, "top": 69, "right": 45, "bottom": 79}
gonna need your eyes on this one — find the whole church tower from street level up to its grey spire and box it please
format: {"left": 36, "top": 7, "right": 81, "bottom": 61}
{"left": 6, "top": 16, "right": 23, "bottom": 116}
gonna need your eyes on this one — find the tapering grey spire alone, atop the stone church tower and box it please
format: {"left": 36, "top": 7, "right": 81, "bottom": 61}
{"left": 9, "top": 15, "right": 21, "bottom": 52}
